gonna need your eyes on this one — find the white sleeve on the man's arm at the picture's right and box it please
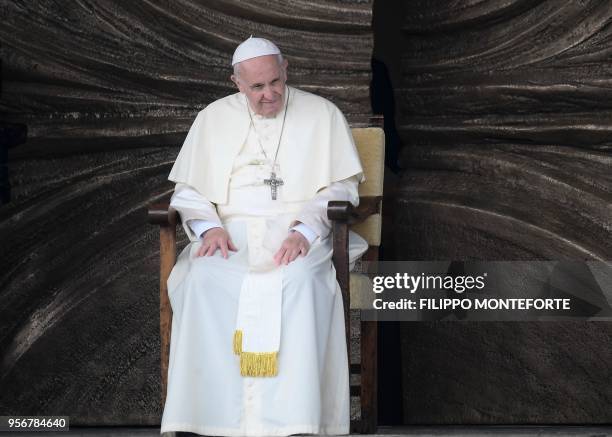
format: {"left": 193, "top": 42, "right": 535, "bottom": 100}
{"left": 296, "top": 176, "right": 359, "bottom": 239}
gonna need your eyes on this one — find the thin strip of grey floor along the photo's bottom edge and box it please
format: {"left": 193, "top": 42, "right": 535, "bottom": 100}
{"left": 9, "top": 425, "right": 612, "bottom": 437}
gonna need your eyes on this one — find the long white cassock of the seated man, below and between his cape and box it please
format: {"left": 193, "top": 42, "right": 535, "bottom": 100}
{"left": 161, "top": 86, "right": 367, "bottom": 436}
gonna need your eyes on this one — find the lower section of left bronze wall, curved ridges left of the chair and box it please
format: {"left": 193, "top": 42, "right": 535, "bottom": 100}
{"left": 0, "top": 148, "right": 175, "bottom": 424}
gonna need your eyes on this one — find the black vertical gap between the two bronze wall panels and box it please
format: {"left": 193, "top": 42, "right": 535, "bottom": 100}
{"left": 370, "top": 0, "right": 405, "bottom": 425}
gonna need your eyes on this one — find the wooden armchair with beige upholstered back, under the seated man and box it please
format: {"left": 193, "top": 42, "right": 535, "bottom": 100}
{"left": 149, "top": 122, "right": 385, "bottom": 434}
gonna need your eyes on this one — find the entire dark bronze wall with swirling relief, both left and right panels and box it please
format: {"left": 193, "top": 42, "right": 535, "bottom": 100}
{"left": 0, "top": 0, "right": 612, "bottom": 425}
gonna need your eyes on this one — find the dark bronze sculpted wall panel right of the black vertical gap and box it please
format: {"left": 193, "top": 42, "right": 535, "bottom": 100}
{"left": 394, "top": 0, "right": 612, "bottom": 423}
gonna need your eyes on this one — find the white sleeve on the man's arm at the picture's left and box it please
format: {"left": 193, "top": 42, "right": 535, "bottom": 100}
{"left": 170, "top": 184, "right": 223, "bottom": 241}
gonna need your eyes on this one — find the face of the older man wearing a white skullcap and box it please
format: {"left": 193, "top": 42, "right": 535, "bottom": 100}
{"left": 232, "top": 55, "right": 287, "bottom": 116}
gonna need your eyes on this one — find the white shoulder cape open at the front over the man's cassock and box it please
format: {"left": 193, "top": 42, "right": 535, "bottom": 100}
{"left": 168, "top": 88, "right": 363, "bottom": 204}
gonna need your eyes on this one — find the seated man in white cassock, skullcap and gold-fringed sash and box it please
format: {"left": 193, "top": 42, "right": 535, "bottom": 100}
{"left": 161, "top": 38, "right": 367, "bottom": 436}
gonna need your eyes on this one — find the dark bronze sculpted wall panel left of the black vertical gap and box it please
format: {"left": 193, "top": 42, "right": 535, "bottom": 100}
{"left": 0, "top": 0, "right": 373, "bottom": 425}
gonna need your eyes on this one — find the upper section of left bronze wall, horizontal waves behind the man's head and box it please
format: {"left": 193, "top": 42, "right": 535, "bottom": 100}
{"left": 0, "top": 0, "right": 372, "bottom": 150}
